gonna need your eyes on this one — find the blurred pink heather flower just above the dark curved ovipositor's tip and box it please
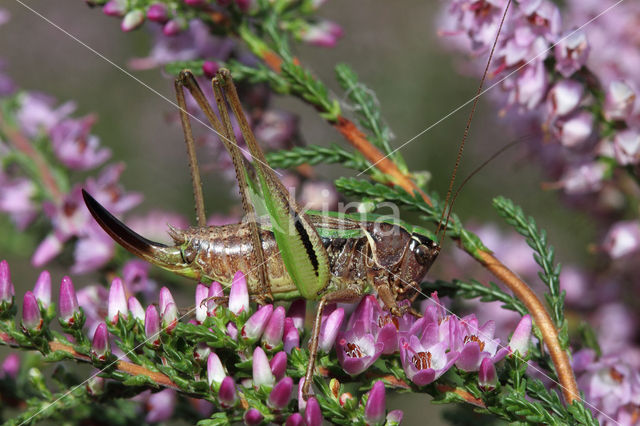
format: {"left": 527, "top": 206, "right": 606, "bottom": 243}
{"left": 49, "top": 116, "right": 111, "bottom": 170}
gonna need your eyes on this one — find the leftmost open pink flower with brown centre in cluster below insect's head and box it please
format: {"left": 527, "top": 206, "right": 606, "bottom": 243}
{"left": 336, "top": 321, "right": 384, "bottom": 376}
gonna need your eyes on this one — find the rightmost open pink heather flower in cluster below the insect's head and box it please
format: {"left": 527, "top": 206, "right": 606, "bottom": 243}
{"left": 456, "top": 315, "right": 509, "bottom": 371}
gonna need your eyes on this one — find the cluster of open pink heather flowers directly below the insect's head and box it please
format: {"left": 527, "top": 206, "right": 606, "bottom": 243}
{"left": 336, "top": 293, "right": 531, "bottom": 388}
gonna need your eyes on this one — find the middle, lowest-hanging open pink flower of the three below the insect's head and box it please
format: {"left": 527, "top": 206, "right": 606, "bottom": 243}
{"left": 400, "top": 335, "right": 459, "bottom": 386}
